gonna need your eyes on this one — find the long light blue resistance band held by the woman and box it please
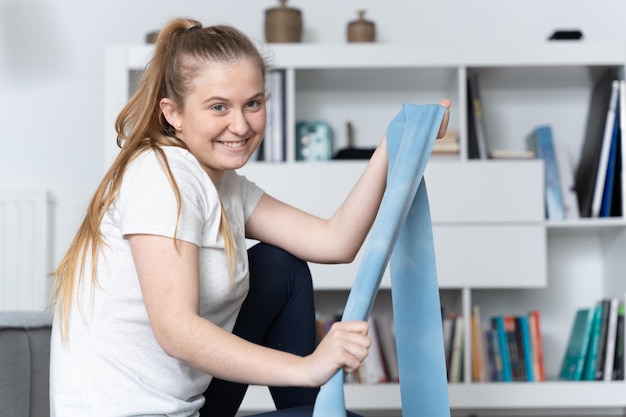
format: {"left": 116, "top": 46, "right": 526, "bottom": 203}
{"left": 313, "top": 104, "right": 450, "bottom": 417}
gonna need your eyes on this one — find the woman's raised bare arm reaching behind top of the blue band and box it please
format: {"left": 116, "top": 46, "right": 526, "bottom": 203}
{"left": 246, "top": 99, "right": 450, "bottom": 263}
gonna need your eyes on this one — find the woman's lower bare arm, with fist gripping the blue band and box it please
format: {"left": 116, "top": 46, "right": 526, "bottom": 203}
{"left": 128, "top": 235, "right": 370, "bottom": 386}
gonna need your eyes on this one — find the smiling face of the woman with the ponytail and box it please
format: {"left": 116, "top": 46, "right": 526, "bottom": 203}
{"left": 161, "top": 59, "right": 265, "bottom": 184}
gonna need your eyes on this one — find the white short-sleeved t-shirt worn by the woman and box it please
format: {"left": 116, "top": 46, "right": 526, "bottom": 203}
{"left": 50, "top": 147, "right": 263, "bottom": 417}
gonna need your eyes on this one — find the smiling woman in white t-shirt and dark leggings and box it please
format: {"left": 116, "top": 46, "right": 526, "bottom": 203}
{"left": 51, "top": 19, "right": 449, "bottom": 417}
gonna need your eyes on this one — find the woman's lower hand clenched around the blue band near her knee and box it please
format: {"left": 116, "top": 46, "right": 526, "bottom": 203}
{"left": 304, "top": 321, "right": 372, "bottom": 387}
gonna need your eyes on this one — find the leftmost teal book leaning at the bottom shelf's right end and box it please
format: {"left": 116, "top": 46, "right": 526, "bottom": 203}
{"left": 559, "top": 308, "right": 593, "bottom": 381}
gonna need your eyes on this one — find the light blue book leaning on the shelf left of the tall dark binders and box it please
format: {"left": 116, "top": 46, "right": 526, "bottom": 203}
{"left": 529, "top": 126, "right": 565, "bottom": 220}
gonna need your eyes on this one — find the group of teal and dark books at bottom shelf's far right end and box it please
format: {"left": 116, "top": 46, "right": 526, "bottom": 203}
{"left": 559, "top": 297, "right": 624, "bottom": 381}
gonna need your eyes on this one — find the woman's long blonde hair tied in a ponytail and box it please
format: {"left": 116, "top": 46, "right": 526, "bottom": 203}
{"left": 52, "top": 18, "right": 267, "bottom": 340}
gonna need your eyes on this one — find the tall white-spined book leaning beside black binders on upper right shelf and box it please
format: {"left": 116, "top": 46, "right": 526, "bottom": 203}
{"left": 591, "top": 80, "right": 619, "bottom": 217}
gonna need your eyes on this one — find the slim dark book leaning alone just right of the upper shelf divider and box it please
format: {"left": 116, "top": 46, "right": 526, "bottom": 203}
{"left": 467, "top": 70, "right": 489, "bottom": 159}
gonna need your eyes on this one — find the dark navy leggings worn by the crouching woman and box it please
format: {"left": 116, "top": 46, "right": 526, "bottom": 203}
{"left": 200, "top": 243, "right": 318, "bottom": 417}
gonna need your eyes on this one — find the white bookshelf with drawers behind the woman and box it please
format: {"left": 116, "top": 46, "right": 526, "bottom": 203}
{"left": 103, "top": 42, "right": 626, "bottom": 416}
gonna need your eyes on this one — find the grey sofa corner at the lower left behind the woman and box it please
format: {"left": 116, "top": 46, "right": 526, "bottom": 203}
{"left": 0, "top": 311, "right": 52, "bottom": 417}
